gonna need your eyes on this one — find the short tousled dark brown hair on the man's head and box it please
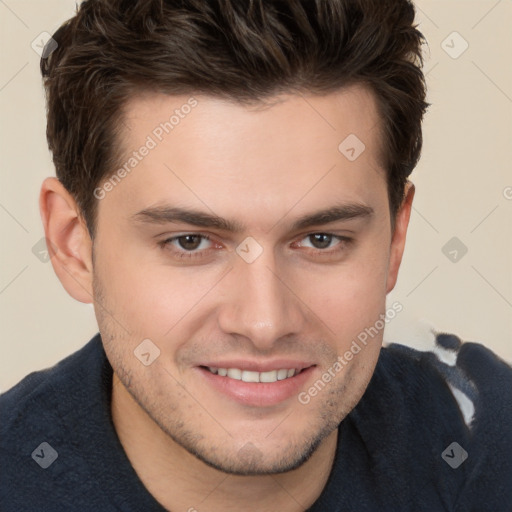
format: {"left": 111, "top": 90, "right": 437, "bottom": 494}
{"left": 41, "top": 0, "right": 429, "bottom": 236}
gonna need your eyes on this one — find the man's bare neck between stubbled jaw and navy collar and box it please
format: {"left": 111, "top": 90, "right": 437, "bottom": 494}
{"left": 111, "top": 373, "right": 338, "bottom": 512}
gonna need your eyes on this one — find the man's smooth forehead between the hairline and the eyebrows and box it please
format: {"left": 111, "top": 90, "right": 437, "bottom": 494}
{"left": 100, "top": 86, "right": 386, "bottom": 232}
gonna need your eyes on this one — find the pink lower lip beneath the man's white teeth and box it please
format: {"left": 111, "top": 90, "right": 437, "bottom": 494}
{"left": 196, "top": 366, "right": 315, "bottom": 407}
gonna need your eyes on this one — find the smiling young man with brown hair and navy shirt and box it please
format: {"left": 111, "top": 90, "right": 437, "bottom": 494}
{"left": 0, "top": 0, "right": 512, "bottom": 512}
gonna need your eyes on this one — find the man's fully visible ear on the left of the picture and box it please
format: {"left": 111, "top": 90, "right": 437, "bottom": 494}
{"left": 39, "top": 178, "right": 93, "bottom": 303}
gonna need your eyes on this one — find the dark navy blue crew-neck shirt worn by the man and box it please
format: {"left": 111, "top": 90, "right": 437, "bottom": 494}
{"left": 0, "top": 334, "right": 512, "bottom": 512}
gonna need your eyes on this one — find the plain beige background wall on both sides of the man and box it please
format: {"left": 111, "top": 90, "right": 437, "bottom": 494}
{"left": 0, "top": 0, "right": 512, "bottom": 391}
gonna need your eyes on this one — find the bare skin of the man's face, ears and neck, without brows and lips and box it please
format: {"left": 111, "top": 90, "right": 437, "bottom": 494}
{"left": 40, "top": 86, "right": 414, "bottom": 512}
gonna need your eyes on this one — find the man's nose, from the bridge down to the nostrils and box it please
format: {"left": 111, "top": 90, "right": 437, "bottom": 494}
{"left": 218, "top": 246, "right": 305, "bottom": 351}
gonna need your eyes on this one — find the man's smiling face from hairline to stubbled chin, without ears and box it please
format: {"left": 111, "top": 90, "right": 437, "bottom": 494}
{"left": 93, "top": 87, "right": 404, "bottom": 474}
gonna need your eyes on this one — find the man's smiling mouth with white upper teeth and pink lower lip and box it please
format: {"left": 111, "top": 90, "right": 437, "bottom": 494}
{"left": 196, "top": 365, "right": 316, "bottom": 407}
